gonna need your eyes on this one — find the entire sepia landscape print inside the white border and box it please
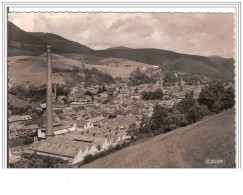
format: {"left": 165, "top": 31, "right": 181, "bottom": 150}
{"left": 8, "top": 13, "right": 236, "bottom": 168}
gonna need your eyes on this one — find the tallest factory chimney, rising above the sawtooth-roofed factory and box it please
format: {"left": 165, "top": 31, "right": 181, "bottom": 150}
{"left": 46, "top": 45, "right": 53, "bottom": 138}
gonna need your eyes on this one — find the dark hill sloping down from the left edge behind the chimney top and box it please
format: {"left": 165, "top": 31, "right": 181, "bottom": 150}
{"left": 8, "top": 22, "right": 91, "bottom": 56}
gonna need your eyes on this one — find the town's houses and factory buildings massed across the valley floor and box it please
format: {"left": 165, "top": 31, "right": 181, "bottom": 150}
{"left": 9, "top": 67, "right": 208, "bottom": 164}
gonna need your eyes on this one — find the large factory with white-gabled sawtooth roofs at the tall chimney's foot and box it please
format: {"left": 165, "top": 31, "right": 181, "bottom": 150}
{"left": 29, "top": 116, "right": 139, "bottom": 164}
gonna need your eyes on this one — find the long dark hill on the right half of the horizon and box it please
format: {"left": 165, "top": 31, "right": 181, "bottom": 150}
{"left": 88, "top": 49, "right": 234, "bottom": 80}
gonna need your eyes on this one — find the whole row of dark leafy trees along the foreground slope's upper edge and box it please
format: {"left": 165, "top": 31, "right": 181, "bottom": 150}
{"left": 130, "top": 83, "right": 235, "bottom": 139}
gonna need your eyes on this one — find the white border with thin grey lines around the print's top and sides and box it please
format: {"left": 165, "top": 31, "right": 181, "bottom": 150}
{"left": 0, "top": 2, "right": 241, "bottom": 169}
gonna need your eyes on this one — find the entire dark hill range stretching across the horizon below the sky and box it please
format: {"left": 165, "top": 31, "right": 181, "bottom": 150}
{"left": 8, "top": 22, "right": 234, "bottom": 80}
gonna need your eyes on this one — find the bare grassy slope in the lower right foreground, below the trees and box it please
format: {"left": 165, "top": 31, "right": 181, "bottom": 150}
{"left": 83, "top": 109, "right": 235, "bottom": 168}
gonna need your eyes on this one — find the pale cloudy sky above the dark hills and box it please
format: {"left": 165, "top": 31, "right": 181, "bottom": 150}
{"left": 9, "top": 13, "right": 234, "bottom": 57}
